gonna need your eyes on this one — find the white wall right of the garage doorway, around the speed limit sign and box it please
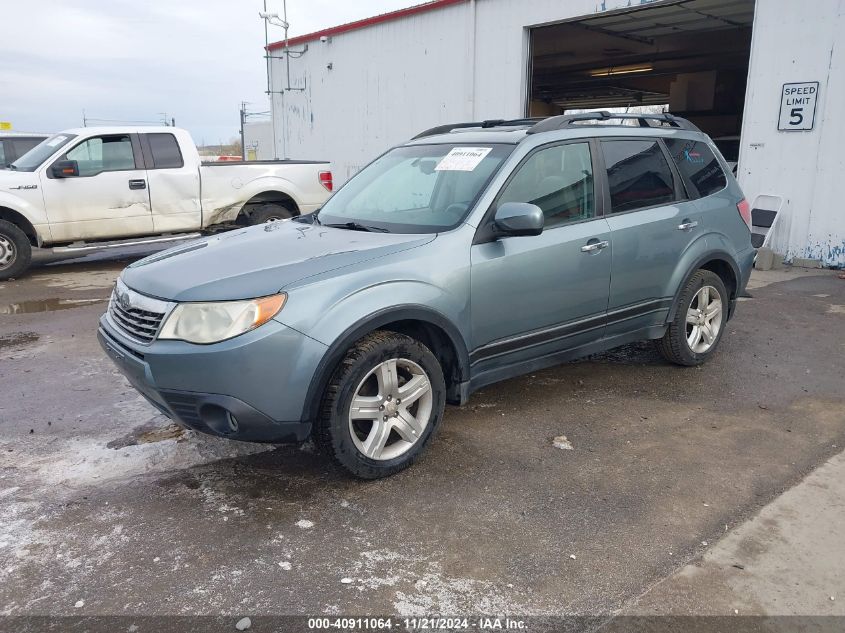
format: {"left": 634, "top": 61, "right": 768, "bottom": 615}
{"left": 739, "top": 0, "right": 845, "bottom": 266}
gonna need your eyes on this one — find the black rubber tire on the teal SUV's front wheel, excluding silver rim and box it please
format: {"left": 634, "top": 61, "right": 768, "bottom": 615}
{"left": 314, "top": 330, "right": 446, "bottom": 479}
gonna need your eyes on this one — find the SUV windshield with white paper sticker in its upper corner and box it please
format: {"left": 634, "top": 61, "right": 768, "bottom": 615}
{"left": 318, "top": 143, "right": 514, "bottom": 233}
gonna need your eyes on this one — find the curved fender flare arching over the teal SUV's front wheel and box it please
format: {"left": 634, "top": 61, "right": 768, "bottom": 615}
{"left": 302, "top": 305, "right": 470, "bottom": 421}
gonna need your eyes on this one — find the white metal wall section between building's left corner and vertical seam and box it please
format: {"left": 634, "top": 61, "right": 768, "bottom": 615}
{"left": 273, "top": 5, "right": 470, "bottom": 183}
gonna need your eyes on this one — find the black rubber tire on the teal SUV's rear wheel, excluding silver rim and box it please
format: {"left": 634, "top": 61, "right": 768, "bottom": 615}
{"left": 655, "top": 269, "right": 730, "bottom": 367}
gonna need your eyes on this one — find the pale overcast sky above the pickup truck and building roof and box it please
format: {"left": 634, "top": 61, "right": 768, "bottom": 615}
{"left": 0, "top": 0, "right": 419, "bottom": 144}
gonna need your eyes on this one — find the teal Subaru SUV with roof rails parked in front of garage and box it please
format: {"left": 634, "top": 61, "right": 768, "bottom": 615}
{"left": 98, "top": 112, "right": 754, "bottom": 478}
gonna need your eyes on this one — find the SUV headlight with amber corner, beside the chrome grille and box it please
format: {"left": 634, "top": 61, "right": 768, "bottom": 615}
{"left": 158, "top": 293, "right": 287, "bottom": 344}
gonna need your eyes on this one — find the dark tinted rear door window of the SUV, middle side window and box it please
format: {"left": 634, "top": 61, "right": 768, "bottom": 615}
{"left": 601, "top": 139, "right": 675, "bottom": 213}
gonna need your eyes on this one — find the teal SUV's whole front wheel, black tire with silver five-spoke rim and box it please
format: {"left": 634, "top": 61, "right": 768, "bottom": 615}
{"left": 315, "top": 331, "right": 446, "bottom": 479}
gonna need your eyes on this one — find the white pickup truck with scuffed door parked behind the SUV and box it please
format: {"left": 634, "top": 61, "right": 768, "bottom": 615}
{"left": 0, "top": 127, "right": 332, "bottom": 280}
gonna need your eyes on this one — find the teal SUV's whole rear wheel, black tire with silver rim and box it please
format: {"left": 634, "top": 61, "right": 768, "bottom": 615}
{"left": 656, "top": 270, "right": 729, "bottom": 366}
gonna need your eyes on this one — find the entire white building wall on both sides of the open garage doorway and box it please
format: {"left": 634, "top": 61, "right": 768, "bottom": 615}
{"left": 273, "top": 0, "right": 845, "bottom": 266}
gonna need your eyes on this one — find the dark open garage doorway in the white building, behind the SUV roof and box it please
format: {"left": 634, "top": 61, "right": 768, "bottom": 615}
{"left": 527, "top": 0, "right": 754, "bottom": 161}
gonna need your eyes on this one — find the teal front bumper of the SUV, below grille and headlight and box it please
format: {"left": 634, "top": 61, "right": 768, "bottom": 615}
{"left": 97, "top": 317, "right": 326, "bottom": 443}
